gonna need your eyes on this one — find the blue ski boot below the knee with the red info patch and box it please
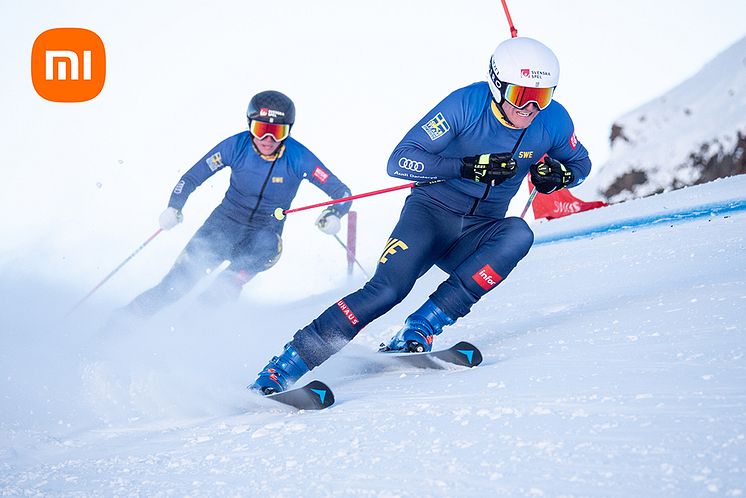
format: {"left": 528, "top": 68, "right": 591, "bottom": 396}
{"left": 380, "top": 299, "right": 455, "bottom": 353}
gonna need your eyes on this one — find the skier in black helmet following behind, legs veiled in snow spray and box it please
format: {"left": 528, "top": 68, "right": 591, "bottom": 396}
{"left": 124, "top": 90, "right": 351, "bottom": 316}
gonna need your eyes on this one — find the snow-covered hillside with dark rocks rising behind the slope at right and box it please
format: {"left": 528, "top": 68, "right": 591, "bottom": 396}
{"left": 584, "top": 37, "right": 746, "bottom": 201}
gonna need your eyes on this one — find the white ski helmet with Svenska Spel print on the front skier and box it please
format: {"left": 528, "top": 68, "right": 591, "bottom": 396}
{"left": 487, "top": 37, "right": 559, "bottom": 109}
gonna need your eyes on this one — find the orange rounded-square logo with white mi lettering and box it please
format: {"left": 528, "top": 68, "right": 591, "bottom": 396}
{"left": 31, "top": 28, "right": 106, "bottom": 102}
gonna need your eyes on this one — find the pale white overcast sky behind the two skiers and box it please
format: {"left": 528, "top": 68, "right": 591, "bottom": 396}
{"left": 0, "top": 0, "right": 746, "bottom": 300}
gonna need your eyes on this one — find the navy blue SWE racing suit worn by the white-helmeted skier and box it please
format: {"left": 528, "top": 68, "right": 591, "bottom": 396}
{"left": 290, "top": 82, "right": 591, "bottom": 368}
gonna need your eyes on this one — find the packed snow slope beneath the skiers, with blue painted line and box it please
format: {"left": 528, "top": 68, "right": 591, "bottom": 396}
{"left": 0, "top": 176, "right": 746, "bottom": 498}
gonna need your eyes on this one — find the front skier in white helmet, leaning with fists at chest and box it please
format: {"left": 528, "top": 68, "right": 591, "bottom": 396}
{"left": 249, "top": 38, "right": 591, "bottom": 394}
